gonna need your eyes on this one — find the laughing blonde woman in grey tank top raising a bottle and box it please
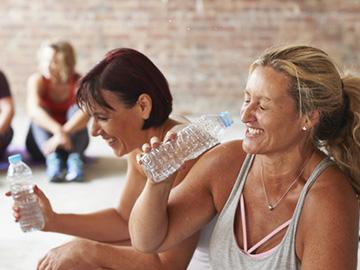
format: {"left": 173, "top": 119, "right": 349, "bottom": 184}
{"left": 129, "top": 46, "right": 360, "bottom": 270}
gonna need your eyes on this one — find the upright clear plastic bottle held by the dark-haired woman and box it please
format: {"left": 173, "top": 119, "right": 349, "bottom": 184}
{"left": 7, "top": 155, "right": 45, "bottom": 232}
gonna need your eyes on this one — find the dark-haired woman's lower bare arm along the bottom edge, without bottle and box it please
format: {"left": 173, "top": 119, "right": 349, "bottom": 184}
{"left": 38, "top": 235, "right": 198, "bottom": 270}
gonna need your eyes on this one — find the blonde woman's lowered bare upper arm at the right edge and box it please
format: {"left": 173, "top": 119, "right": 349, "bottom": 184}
{"left": 296, "top": 168, "right": 359, "bottom": 270}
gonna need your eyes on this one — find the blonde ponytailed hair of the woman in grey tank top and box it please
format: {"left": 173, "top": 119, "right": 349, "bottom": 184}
{"left": 250, "top": 46, "right": 360, "bottom": 194}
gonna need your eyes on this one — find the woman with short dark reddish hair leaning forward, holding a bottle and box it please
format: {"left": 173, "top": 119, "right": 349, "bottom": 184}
{"left": 8, "top": 48, "right": 211, "bottom": 270}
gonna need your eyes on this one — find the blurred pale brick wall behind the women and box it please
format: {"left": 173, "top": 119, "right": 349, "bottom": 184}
{"left": 0, "top": 0, "right": 360, "bottom": 113}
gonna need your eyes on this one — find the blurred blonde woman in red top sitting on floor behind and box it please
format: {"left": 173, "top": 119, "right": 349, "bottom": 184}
{"left": 26, "top": 41, "right": 89, "bottom": 182}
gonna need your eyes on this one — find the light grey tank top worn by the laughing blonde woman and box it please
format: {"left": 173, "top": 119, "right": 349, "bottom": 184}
{"left": 210, "top": 155, "right": 333, "bottom": 270}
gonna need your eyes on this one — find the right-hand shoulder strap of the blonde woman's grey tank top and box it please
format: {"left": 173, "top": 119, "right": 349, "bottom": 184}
{"left": 290, "top": 158, "right": 334, "bottom": 231}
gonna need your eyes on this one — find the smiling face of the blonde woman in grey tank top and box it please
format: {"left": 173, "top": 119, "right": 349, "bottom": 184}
{"left": 241, "top": 66, "right": 303, "bottom": 154}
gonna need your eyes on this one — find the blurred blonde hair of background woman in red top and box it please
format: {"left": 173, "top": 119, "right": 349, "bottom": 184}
{"left": 38, "top": 41, "right": 76, "bottom": 82}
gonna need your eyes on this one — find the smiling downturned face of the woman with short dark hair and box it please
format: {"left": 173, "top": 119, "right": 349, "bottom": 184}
{"left": 91, "top": 90, "right": 144, "bottom": 156}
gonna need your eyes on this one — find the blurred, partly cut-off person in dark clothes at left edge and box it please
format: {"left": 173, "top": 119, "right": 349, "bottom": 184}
{"left": 0, "top": 71, "right": 15, "bottom": 158}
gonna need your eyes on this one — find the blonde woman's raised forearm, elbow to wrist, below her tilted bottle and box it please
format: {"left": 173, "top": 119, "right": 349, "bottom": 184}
{"left": 129, "top": 180, "right": 172, "bottom": 252}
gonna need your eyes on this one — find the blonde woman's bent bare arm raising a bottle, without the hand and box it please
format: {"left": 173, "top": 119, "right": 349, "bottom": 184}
{"left": 129, "top": 142, "right": 236, "bottom": 252}
